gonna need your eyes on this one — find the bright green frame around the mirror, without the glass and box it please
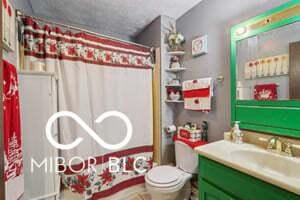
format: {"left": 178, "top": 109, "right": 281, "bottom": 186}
{"left": 231, "top": 0, "right": 300, "bottom": 138}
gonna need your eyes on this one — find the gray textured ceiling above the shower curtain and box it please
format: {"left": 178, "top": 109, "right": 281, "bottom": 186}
{"left": 15, "top": 0, "right": 201, "bottom": 38}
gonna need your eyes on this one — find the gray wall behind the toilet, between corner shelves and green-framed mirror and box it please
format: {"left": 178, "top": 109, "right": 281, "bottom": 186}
{"left": 176, "top": 0, "right": 288, "bottom": 141}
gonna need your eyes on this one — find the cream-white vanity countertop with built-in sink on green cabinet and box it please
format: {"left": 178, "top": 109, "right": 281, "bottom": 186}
{"left": 195, "top": 140, "right": 300, "bottom": 195}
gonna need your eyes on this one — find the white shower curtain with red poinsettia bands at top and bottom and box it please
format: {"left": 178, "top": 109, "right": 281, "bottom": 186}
{"left": 23, "top": 17, "right": 153, "bottom": 199}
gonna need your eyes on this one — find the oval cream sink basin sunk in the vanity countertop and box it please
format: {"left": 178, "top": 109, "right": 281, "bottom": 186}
{"left": 231, "top": 150, "right": 300, "bottom": 181}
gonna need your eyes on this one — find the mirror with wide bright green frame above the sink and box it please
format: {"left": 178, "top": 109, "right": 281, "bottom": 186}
{"left": 231, "top": 0, "right": 300, "bottom": 138}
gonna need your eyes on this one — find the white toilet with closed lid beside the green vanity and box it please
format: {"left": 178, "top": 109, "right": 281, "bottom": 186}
{"left": 145, "top": 141, "right": 198, "bottom": 200}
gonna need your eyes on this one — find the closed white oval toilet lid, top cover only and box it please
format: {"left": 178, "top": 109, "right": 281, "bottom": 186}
{"left": 147, "top": 166, "right": 182, "bottom": 186}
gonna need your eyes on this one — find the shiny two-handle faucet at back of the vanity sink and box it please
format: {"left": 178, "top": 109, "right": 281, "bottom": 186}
{"left": 267, "top": 137, "right": 293, "bottom": 157}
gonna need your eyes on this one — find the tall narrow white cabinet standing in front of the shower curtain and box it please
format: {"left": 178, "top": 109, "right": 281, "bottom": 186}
{"left": 19, "top": 74, "right": 59, "bottom": 200}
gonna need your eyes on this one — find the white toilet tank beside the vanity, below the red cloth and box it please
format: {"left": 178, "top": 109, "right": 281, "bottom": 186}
{"left": 175, "top": 141, "right": 198, "bottom": 174}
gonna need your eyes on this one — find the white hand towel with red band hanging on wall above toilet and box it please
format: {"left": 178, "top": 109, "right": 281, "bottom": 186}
{"left": 182, "top": 78, "right": 213, "bottom": 112}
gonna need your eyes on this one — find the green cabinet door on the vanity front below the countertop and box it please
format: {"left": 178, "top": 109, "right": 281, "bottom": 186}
{"left": 199, "top": 179, "right": 235, "bottom": 200}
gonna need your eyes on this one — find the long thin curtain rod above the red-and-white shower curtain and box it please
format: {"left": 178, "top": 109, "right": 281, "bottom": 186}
{"left": 17, "top": 9, "right": 151, "bottom": 48}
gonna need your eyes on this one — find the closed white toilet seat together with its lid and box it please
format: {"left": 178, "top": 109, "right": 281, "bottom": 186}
{"left": 145, "top": 166, "right": 186, "bottom": 188}
